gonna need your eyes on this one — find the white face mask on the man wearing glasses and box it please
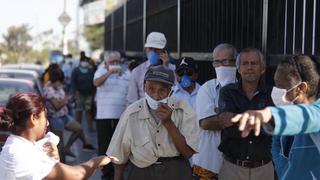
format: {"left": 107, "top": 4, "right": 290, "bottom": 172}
{"left": 215, "top": 66, "right": 237, "bottom": 87}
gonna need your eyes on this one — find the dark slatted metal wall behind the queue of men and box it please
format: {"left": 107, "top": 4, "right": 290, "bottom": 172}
{"left": 105, "top": 0, "right": 320, "bottom": 84}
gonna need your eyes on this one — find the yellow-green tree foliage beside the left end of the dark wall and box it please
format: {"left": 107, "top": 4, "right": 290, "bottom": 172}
{"left": 83, "top": 24, "right": 104, "bottom": 51}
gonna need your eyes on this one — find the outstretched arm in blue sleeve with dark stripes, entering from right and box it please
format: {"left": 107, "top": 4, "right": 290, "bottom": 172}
{"left": 232, "top": 100, "right": 320, "bottom": 137}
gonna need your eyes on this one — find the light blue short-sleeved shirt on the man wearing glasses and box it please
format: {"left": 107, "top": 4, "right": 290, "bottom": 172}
{"left": 192, "top": 79, "right": 222, "bottom": 173}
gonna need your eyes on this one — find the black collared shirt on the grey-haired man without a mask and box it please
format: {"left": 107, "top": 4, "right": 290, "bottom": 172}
{"left": 219, "top": 81, "right": 273, "bottom": 161}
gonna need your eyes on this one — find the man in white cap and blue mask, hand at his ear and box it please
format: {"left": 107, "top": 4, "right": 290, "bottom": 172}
{"left": 127, "top": 32, "right": 175, "bottom": 105}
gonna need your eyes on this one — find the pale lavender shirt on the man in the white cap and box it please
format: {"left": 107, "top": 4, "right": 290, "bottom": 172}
{"left": 127, "top": 61, "right": 175, "bottom": 105}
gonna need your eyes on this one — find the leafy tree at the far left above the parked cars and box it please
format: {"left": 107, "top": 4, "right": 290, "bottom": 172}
{"left": 2, "top": 24, "right": 32, "bottom": 63}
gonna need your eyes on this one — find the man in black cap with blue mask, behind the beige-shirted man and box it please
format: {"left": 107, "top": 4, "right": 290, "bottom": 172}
{"left": 173, "top": 57, "right": 200, "bottom": 111}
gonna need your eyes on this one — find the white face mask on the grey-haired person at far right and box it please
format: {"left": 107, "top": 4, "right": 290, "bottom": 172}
{"left": 271, "top": 83, "right": 301, "bottom": 106}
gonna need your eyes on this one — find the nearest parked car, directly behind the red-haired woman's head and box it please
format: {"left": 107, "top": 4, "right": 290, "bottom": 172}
{"left": 0, "top": 78, "right": 40, "bottom": 151}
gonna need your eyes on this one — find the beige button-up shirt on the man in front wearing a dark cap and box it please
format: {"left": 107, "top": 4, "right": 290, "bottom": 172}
{"left": 106, "top": 97, "right": 199, "bottom": 168}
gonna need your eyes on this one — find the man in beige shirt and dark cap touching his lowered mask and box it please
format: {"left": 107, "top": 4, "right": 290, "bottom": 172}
{"left": 106, "top": 65, "right": 199, "bottom": 180}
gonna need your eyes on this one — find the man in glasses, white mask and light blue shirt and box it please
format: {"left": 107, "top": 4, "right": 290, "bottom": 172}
{"left": 193, "top": 44, "right": 237, "bottom": 179}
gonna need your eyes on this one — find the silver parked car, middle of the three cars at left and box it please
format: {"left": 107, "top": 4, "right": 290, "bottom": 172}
{"left": 0, "top": 68, "right": 42, "bottom": 94}
